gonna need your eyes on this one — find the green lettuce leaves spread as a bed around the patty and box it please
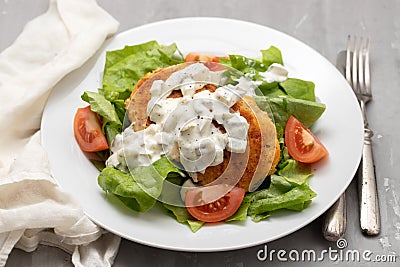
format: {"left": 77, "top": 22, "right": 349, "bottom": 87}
{"left": 82, "top": 41, "right": 325, "bottom": 232}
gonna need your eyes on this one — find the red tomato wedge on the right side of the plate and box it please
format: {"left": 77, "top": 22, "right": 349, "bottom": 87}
{"left": 285, "top": 116, "right": 329, "bottom": 163}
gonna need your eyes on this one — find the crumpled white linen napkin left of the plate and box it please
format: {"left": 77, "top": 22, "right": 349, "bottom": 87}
{"left": 0, "top": 0, "right": 120, "bottom": 266}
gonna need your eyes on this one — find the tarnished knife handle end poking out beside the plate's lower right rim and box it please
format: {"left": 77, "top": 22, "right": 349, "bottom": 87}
{"left": 322, "top": 193, "right": 347, "bottom": 241}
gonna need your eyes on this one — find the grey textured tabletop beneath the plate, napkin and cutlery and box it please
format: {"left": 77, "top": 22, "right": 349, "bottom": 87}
{"left": 0, "top": 0, "right": 400, "bottom": 267}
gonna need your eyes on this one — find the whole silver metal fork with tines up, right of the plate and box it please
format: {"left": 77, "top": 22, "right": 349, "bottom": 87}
{"left": 345, "top": 35, "right": 381, "bottom": 235}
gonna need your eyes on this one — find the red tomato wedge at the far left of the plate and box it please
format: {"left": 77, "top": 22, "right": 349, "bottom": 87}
{"left": 74, "top": 106, "right": 108, "bottom": 152}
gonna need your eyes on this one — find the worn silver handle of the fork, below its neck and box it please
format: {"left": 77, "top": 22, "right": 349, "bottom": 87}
{"left": 358, "top": 128, "right": 381, "bottom": 235}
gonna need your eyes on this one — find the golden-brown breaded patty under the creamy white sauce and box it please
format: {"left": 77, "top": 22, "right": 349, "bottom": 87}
{"left": 125, "top": 64, "right": 280, "bottom": 191}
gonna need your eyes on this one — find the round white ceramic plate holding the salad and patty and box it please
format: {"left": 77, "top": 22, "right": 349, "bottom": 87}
{"left": 42, "top": 18, "right": 363, "bottom": 251}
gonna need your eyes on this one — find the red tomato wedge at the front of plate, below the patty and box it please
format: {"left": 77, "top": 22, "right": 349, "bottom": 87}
{"left": 185, "top": 185, "right": 246, "bottom": 222}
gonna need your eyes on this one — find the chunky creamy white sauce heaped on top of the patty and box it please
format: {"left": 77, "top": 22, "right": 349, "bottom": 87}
{"left": 106, "top": 63, "right": 255, "bottom": 176}
